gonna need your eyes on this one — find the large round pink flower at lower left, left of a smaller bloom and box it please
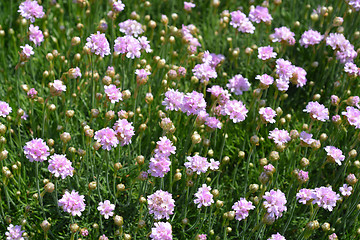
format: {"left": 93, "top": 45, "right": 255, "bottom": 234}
{"left": 58, "top": 190, "right": 86, "bottom": 217}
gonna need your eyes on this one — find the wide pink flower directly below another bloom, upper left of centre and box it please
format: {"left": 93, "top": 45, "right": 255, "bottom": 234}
{"left": 114, "top": 35, "right": 143, "bottom": 59}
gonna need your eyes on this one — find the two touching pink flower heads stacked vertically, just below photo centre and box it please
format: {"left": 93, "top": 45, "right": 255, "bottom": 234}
{"left": 148, "top": 136, "right": 176, "bottom": 178}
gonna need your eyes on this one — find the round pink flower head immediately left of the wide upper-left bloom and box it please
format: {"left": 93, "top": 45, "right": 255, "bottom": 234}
{"left": 85, "top": 31, "right": 110, "bottom": 57}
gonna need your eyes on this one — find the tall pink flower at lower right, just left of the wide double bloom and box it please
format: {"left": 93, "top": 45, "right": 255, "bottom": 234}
{"left": 263, "top": 190, "right": 287, "bottom": 219}
